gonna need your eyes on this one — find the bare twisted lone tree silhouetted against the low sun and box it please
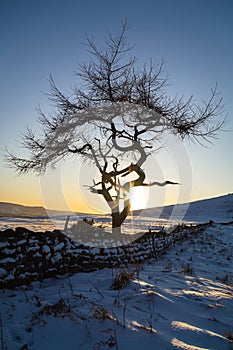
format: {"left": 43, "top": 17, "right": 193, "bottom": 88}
{"left": 6, "top": 21, "right": 224, "bottom": 232}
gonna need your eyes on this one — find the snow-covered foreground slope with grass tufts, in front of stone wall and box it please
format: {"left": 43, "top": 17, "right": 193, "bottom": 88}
{"left": 0, "top": 225, "right": 233, "bottom": 350}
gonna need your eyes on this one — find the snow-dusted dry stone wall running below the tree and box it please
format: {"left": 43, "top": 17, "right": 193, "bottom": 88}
{"left": 0, "top": 224, "right": 207, "bottom": 289}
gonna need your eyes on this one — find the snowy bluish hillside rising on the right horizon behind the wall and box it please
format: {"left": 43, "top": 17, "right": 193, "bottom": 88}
{"left": 134, "top": 193, "right": 233, "bottom": 222}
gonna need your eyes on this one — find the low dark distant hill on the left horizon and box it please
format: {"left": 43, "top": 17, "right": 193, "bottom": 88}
{"left": 0, "top": 202, "right": 70, "bottom": 217}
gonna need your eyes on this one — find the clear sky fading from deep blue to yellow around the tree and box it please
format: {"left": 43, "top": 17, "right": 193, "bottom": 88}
{"left": 0, "top": 0, "right": 233, "bottom": 211}
